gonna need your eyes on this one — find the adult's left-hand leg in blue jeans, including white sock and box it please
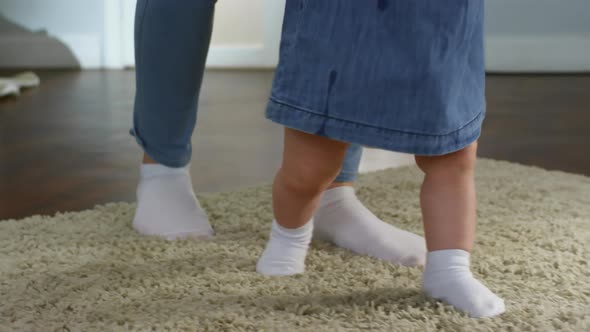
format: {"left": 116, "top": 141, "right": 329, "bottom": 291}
{"left": 132, "top": 0, "right": 215, "bottom": 239}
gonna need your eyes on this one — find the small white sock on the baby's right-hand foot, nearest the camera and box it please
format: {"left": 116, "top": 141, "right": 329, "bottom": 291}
{"left": 422, "top": 249, "right": 506, "bottom": 318}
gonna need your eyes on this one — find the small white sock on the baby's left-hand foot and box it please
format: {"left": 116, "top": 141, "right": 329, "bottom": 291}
{"left": 256, "top": 220, "right": 313, "bottom": 276}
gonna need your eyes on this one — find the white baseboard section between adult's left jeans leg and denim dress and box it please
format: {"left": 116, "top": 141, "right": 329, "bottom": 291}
{"left": 207, "top": 44, "right": 278, "bottom": 68}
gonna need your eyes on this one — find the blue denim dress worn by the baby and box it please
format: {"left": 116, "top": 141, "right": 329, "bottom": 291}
{"left": 266, "top": 0, "right": 485, "bottom": 155}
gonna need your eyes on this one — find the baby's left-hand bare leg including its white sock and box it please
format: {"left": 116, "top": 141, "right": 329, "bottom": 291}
{"left": 257, "top": 129, "right": 348, "bottom": 275}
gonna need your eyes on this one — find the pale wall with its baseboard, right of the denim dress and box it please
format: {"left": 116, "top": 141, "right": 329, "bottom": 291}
{"left": 485, "top": 0, "right": 590, "bottom": 72}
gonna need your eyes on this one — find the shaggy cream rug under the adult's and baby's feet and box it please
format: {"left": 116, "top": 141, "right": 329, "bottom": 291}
{"left": 0, "top": 160, "right": 590, "bottom": 331}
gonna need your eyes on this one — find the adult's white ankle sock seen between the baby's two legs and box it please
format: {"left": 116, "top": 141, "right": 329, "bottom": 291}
{"left": 314, "top": 187, "right": 426, "bottom": 266}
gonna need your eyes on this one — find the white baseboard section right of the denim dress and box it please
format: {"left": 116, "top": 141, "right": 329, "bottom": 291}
{"left": 486, "top": 35, "right": 590, "bottom": 73}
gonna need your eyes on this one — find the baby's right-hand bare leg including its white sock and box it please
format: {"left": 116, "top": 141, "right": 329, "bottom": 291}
{"left": 416, "top": 143, "right": 505, "bottom": 317}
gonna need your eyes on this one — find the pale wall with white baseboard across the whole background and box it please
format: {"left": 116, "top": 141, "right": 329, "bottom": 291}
{"left": 0, "top": 0, "right": 590, "bottom": 72}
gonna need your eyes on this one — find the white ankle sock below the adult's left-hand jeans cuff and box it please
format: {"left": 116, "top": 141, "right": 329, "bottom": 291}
{"left": 133, "top": 164, "right": 213, "bottom": 240}
